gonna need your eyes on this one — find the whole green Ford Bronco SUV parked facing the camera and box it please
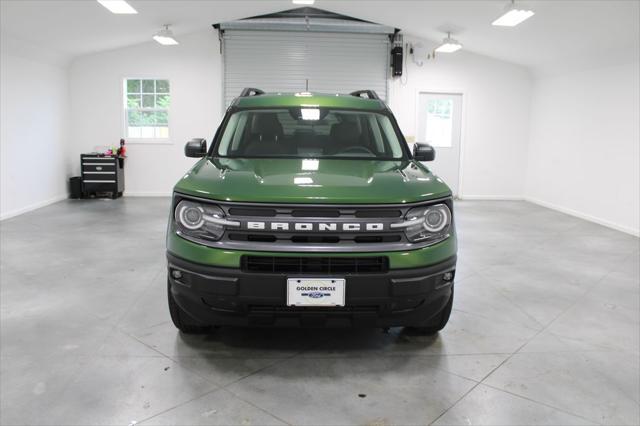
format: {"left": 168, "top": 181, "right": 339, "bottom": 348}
{"left": 167, "top": 88, "right": 456, "bottom": 334}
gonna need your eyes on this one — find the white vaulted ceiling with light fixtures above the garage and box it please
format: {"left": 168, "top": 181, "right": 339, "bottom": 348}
{"left": 0, "top": 0, "right": 640, "bottom": 73}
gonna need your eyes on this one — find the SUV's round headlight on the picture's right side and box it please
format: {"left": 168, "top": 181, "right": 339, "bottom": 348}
{"left": 404, "top": 204, "right": 451, "bottom": 244}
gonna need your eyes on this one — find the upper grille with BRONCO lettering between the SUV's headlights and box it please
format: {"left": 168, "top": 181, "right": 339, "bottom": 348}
{"left": 186, "top": 197, "right": 456, "bottom": 256}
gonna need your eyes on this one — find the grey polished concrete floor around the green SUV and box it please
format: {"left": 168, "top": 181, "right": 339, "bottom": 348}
{"left": 0, "top": 198, "right": 640, "bottom": 425}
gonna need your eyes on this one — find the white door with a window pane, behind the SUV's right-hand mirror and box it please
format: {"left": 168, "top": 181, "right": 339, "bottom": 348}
{"left": 416, "top": 92, "right": 462, "bottom": 196}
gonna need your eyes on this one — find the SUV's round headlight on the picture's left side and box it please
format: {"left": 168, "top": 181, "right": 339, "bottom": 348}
{"left": 174, "top": 200, "right": 235, "bottom": 241}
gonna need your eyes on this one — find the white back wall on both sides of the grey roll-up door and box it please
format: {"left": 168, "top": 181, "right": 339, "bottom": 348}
{"left": 71, "top": 30, "right": 530, "bottom": 198}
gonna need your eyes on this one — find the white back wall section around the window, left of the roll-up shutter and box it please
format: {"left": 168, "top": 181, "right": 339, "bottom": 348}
{"left": 70, "top": 29, "right": 222, "bottom": 195}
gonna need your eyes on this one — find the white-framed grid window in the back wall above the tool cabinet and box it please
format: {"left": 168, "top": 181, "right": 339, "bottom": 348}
{"left": 124, "top": 79, "right": 171, "bottom": 140}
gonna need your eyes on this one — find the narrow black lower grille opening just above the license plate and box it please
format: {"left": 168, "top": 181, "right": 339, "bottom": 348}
{"left": 241, "top": 256, "right": 389, "bottom": 275}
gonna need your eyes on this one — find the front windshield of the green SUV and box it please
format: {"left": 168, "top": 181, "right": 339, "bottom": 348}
{"left": 217, "top": 107, "right": 404, "bottom": 160}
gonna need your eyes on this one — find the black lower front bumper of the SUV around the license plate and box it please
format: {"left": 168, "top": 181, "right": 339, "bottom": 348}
{"left": 167, "top": 253, "right": 456, "bottom": 327}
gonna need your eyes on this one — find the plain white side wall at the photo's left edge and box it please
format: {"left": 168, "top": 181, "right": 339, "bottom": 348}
{"left": 0, "top": 34, "right": 70, "bottom": 219}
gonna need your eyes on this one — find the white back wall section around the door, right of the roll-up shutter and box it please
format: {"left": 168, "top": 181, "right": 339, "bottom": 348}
{"left": 389, "top": 36, "right": 532, "bottom": 199}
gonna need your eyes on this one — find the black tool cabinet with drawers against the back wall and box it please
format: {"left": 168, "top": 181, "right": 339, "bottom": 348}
{"left": 80, "top": 154, "right": 124, "bottom": 198}
